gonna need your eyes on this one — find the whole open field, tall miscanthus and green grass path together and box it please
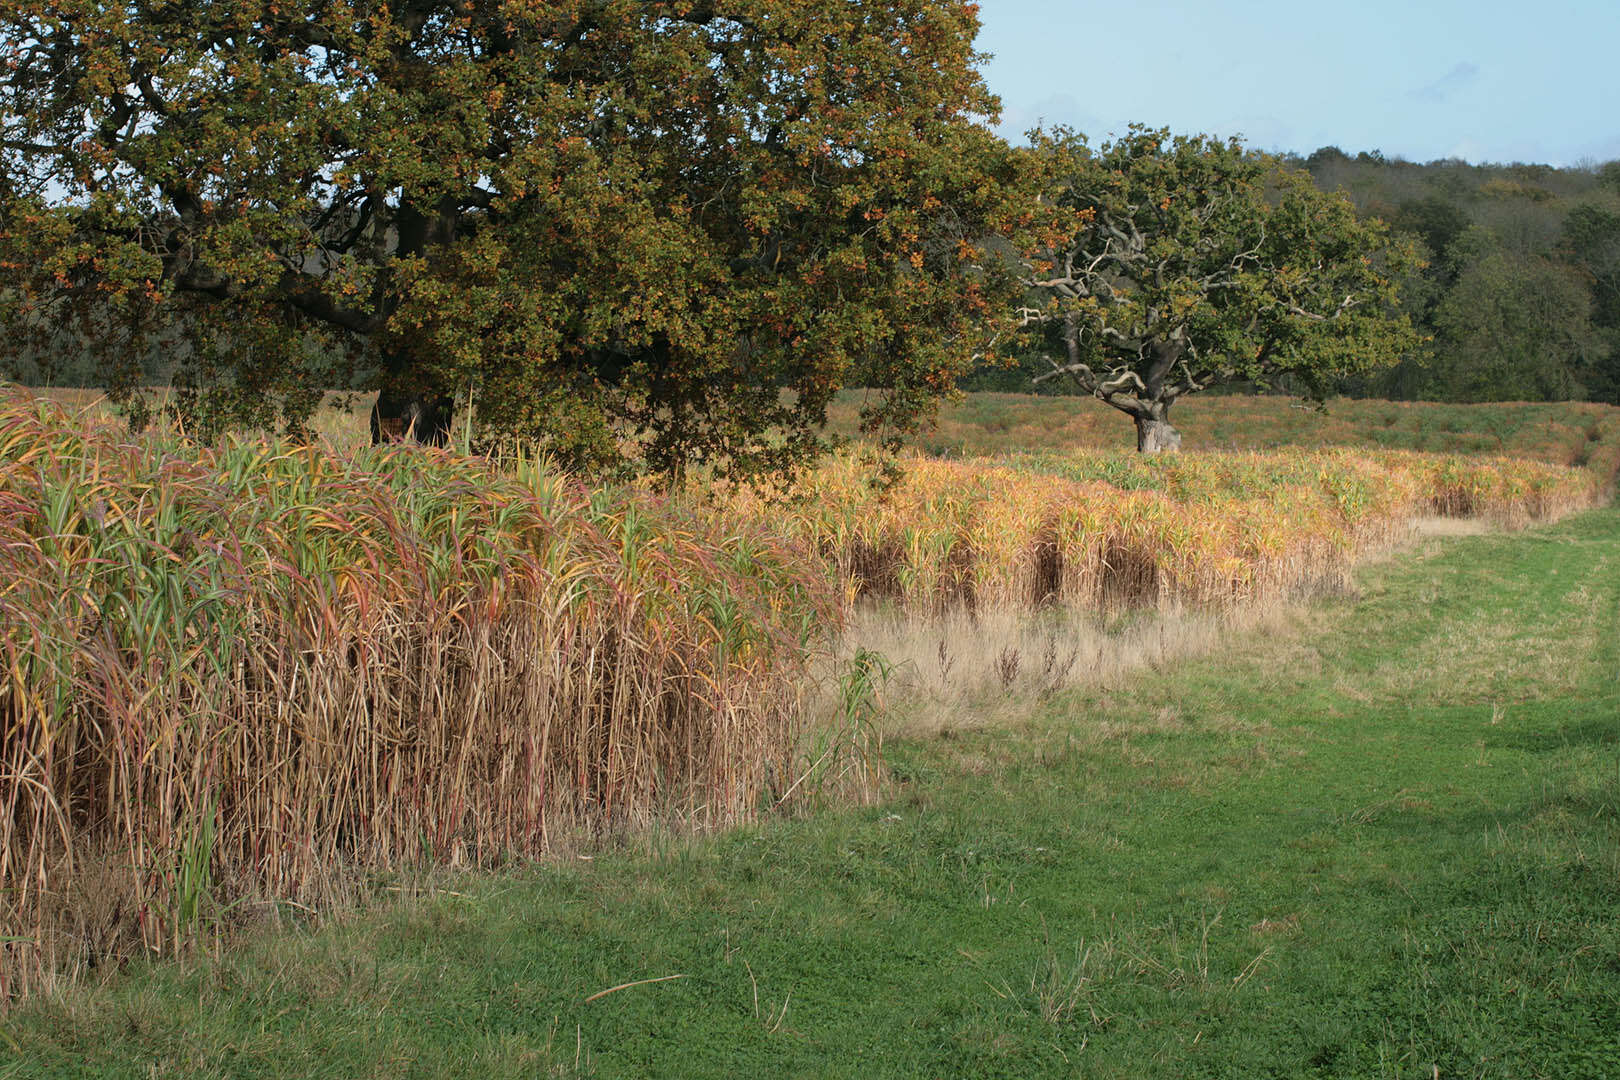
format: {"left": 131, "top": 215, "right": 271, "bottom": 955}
{"left": 0, "top": 383, "right": 1620, "bottom": 1075}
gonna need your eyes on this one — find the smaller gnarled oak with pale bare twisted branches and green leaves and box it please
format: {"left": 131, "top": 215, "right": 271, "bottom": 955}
{"left": 1019, "top": 128, "right": 1413, "bottom": 452}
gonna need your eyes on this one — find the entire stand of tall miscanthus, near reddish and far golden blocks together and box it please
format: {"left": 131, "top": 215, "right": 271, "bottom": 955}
{"left": 0, "top": 383, "right": 1607, "bottom": 1010}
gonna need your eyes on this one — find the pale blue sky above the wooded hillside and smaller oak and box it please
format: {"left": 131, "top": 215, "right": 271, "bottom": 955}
{"left": 978, "top": 0, "right": 1620, "bottom": 165}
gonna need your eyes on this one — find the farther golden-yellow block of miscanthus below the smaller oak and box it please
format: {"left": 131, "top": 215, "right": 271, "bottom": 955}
{"left": 721, "top": 449, "right": 1605, "bottom": 615}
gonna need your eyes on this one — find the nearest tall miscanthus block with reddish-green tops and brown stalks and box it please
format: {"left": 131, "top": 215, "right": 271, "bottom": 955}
{"left": 0, "top": 395, "right": 839, "bottom": 996}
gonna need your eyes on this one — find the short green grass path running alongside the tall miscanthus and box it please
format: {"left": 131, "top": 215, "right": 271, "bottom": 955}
{"left": 12, "top": 510, "right": 1620, "bottom": 1077}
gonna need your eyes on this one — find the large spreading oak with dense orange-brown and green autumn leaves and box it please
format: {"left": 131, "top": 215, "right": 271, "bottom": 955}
{"left": 0, "top": 0, "right": 1029, "bottom": 471}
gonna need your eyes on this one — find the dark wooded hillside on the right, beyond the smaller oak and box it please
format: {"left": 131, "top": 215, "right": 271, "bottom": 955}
{"left": 967, "top": 147, "right": 1620, "bottom": 403}
